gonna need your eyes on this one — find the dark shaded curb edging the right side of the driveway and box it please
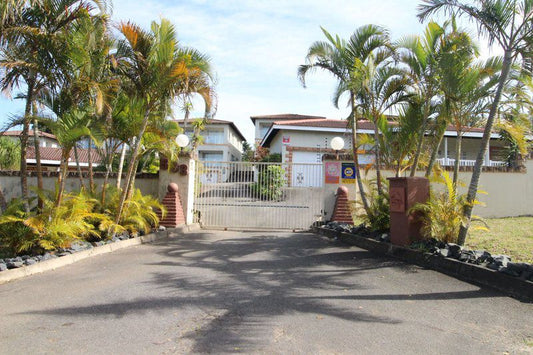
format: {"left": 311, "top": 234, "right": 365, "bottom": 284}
{"left": 312, "top": 227, "right": 533, "bottom": 302}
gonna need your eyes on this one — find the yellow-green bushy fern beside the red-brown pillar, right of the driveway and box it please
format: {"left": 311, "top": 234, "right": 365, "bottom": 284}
{"left": 408, "top": 171, "right": 487, "bottom": 243}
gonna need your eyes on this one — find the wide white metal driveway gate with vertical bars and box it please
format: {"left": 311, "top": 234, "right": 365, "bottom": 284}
{"left": 194, "top": 161, "right": 324, "bottom": 229}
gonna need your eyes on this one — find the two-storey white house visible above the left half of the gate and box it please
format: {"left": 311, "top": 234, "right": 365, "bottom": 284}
{"left": 175, "top": 119, "right": 246, "bottom": 161}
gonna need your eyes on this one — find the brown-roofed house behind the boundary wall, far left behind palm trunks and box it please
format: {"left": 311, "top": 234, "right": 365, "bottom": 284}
{"left": 0, "top": 130, "right": 102, "bottom": 171}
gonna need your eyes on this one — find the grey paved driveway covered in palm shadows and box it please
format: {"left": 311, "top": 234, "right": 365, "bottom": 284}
{"left": 0, "top": 231, "right": 533, "bottom": 354}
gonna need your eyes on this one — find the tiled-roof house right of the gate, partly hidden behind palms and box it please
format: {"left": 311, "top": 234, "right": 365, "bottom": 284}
{"left": 256, "top": 118, "right": 507, "bottom": 167}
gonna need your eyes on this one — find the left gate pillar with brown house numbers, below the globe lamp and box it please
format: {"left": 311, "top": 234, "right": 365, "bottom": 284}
{"left": 158, "top": 153, "right": 196, "bottom": 225}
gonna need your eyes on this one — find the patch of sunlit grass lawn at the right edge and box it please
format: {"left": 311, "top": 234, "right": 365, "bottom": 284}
{"left": 465, "top": 217, "right": 533, "bottom": 263}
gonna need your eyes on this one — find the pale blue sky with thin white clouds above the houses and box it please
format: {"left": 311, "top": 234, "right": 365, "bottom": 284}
{"left": 0, "top": 0, "right": 498, "bottom": 142}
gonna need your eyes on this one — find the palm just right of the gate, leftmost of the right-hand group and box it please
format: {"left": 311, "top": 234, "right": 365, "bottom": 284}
{"left": 298, "top": 25, "right": 391, "bottom": 211}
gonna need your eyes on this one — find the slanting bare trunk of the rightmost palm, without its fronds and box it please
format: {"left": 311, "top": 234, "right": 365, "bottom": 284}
{"left": 457, "top": 49, "right": 513, "bottom": 245}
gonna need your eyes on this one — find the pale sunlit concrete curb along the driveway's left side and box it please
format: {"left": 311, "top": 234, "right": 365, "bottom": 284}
{"left": 0, "top": 224, "right": 199, "bottom": 285}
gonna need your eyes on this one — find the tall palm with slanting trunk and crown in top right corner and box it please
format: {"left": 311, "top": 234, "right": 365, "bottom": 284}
{"left": 418, "top": 0, "right": 533, "bottom": 244}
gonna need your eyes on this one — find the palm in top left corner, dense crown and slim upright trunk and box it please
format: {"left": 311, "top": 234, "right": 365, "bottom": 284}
{"left": 0, "top": 0, "right": 105, "bottom": 211}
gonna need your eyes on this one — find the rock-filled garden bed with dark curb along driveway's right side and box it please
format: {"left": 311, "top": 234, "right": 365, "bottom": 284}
{"left": 313, "top": 222, "right": 533, "bottom": 302}
